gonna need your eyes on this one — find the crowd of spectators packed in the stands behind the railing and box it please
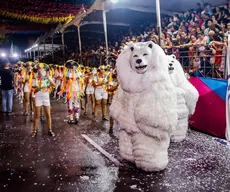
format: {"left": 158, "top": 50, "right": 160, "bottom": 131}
{"left": 40, "top": 0, "right": 230, "bottom": 75}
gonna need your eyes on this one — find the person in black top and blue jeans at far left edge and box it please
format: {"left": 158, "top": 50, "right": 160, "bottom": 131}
{"left": 0, "top": 64, "right": 14, "bottom": 115}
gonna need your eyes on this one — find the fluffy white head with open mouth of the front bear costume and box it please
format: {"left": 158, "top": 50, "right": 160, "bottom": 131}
{"left": 116, "top": 41, "right": 170, "bottom": 93}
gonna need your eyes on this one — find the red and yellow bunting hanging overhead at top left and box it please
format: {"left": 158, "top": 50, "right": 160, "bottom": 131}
{"left": 0, "top": 0, "right": 92, "bottom": 24}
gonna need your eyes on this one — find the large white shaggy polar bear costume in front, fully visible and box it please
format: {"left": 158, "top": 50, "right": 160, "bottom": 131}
{"left": 110, "top": 41, "right": 178, "bottom": 171}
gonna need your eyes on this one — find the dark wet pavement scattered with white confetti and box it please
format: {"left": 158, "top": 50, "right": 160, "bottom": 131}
{"left": 0, "top": 101, "right": 230, "bottom": 192}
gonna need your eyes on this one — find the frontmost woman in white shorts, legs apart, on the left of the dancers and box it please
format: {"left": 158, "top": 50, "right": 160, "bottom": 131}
{"left": 32, "top": 66, "right": 55, "bottom": 137}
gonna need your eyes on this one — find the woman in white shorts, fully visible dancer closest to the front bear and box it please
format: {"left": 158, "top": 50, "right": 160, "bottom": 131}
{"left": 93, "top": 68, "right": 108, "bottom": 122}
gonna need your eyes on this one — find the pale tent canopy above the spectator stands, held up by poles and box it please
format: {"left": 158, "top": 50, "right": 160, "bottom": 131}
{"left": 32, "top": 0, "right": 226, "bottom": 47}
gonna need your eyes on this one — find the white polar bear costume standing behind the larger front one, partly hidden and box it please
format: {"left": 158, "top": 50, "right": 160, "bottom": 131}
{"left": 167, "top": 55, "right": 199, "bottom": 142}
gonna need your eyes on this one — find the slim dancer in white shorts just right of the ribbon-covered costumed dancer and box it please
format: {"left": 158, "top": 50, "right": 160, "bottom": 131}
{"left": 85, "top": 72, "right": 96, "bottom": 115}
